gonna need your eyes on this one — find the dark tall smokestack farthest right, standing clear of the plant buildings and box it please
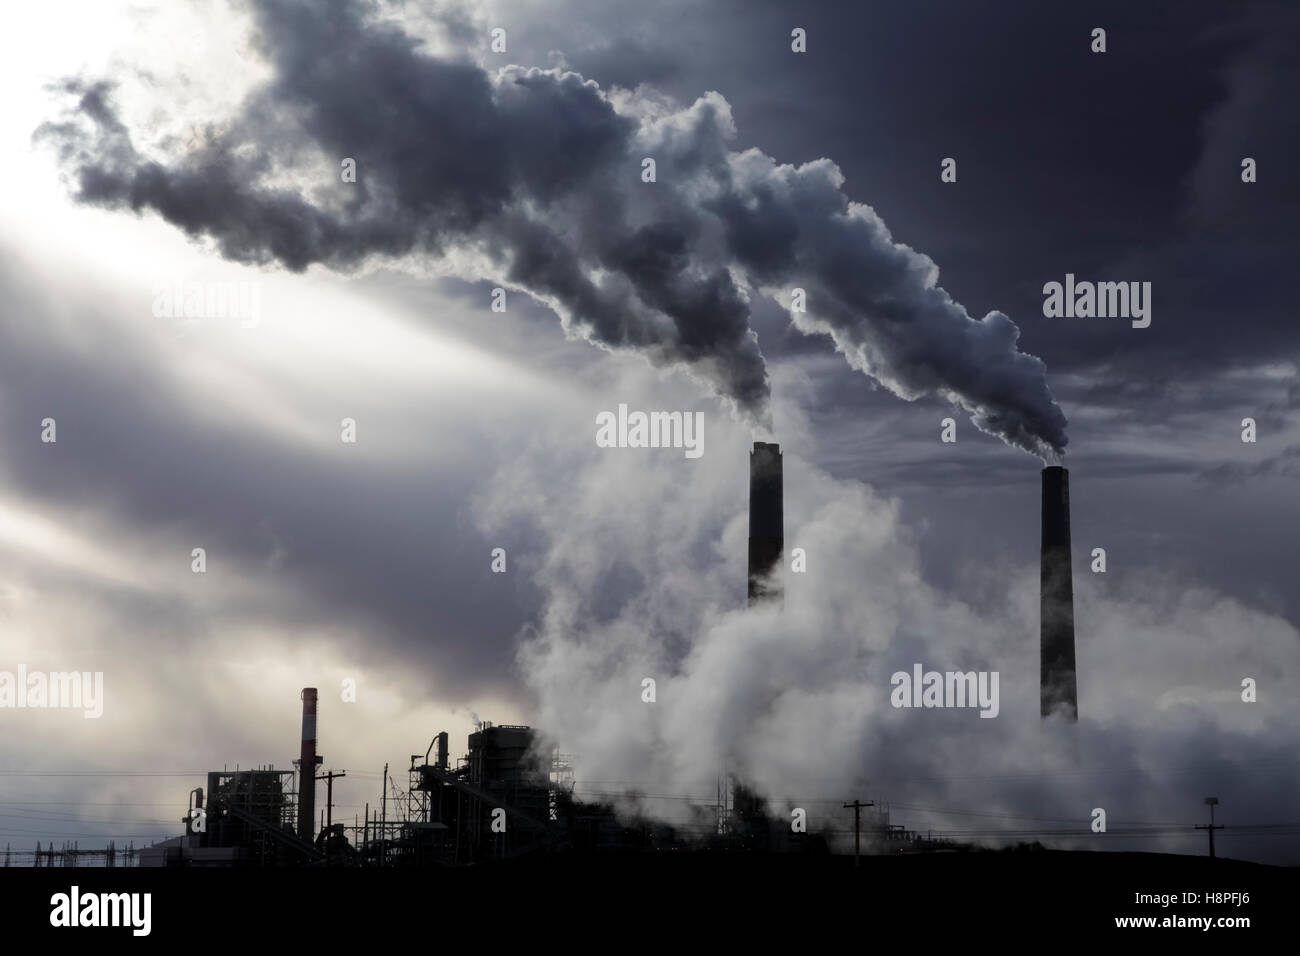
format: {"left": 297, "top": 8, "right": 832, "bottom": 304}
{"left": 1039, "top": 464, "right": 1079, "bottom": 721}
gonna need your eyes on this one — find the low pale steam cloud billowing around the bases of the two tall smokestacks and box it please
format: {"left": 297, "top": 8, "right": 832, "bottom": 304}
{"left": 477, "top": 427, "right": 1300, "bottom": 861}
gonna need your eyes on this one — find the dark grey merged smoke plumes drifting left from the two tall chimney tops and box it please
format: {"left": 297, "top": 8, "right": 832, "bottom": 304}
{"left": 39, "top": 0, "right": 1066, "bottom": 458}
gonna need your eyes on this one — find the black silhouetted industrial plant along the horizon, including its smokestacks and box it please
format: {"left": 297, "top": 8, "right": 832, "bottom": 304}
{"left": 5, "top": 441, "right": 1281, "bottom": 875}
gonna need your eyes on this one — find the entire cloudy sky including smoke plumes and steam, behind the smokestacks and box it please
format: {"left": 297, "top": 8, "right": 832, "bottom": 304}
{"left": 0, "top": 0, "right": 1300, "bottom": 864}
